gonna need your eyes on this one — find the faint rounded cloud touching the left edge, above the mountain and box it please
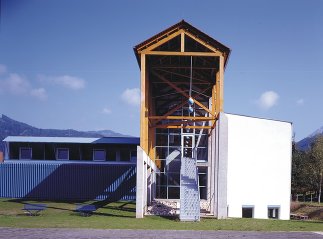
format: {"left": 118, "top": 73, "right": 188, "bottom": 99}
{"left": 0, "top": 73, "right": 31, "bottom": 95}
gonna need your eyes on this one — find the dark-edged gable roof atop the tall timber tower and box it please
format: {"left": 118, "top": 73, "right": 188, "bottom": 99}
{"left": 134, "top": 20, "right": 231, "bottom": 65}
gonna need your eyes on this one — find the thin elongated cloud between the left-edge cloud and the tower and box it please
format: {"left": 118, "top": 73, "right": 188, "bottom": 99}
{"left": 38, "top": 75, "right": 85, "bottom": 90}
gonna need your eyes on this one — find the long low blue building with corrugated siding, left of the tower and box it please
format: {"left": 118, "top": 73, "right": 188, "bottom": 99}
{"left": 0, "top": 136, "right": 139, "bottom": 201}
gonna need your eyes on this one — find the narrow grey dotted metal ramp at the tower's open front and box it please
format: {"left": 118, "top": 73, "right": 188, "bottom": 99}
{"left": 179, "top": 157, "right": 200, "bottom": 221}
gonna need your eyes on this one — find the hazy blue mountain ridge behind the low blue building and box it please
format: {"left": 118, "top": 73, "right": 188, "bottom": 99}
{"left": 0, "top": 114, "right": 127, "bottom": 151}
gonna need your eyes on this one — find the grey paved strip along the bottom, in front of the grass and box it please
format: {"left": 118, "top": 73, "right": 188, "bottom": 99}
{"left": 0, "top": 228, "right": 323, "bottom": 239}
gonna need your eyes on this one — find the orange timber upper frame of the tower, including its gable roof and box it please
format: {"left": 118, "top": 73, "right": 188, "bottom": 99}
{"left": 134, "top": 20, "right": 230, "bottom": 159}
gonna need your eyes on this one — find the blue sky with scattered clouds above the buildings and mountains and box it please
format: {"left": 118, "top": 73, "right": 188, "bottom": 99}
{"left": 0, "top": 0, "right": 323, "bottom": 140}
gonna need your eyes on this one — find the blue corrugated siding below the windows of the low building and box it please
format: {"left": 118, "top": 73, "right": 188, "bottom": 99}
{"left": 0, "top": 162, "right": 136, "bottom": 201}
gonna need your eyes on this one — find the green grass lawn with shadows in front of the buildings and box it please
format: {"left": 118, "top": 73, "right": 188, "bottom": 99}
{"left": 0, "top": 199, "right": 323, "bottom": 231}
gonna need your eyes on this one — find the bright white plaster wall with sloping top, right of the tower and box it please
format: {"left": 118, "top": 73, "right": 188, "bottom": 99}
{"left": 225, "top": 114, "right": 292, "bottom": 220}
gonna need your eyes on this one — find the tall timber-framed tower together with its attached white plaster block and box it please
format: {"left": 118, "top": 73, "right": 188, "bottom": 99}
{"left": 134, "top": 21, "right": 292, "bottom": 221}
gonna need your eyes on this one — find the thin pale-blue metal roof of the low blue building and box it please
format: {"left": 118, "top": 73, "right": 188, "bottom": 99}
{"left": 3, "top": 136, "right": 140, "bottom": 145}
